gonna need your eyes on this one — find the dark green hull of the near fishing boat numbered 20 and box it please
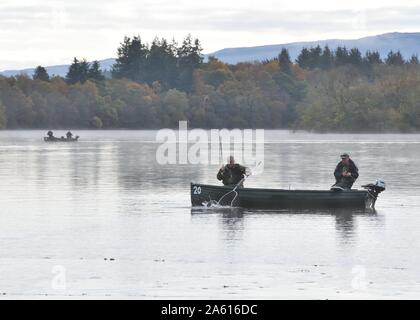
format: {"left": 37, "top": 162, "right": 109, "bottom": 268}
{"left": 191, "top": 183, "right": 372, "bottom": 209}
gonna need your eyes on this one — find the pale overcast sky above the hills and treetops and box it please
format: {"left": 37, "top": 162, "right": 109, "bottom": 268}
{"left": 0, "top": 0, "right": 420, "bottom": 70}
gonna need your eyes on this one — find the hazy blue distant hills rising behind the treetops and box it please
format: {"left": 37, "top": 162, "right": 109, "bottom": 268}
{"left": 0, "top": 32, "right": 420, "bottom": 76}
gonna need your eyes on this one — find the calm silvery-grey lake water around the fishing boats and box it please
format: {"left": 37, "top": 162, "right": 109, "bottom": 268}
{"left": 0, "top": 131, "right": 420, "bottom": 299}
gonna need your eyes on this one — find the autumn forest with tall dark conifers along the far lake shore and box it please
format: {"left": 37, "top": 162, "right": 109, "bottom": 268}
{"left": 0, "top": 36, "right": 420, "bottom": 132}
